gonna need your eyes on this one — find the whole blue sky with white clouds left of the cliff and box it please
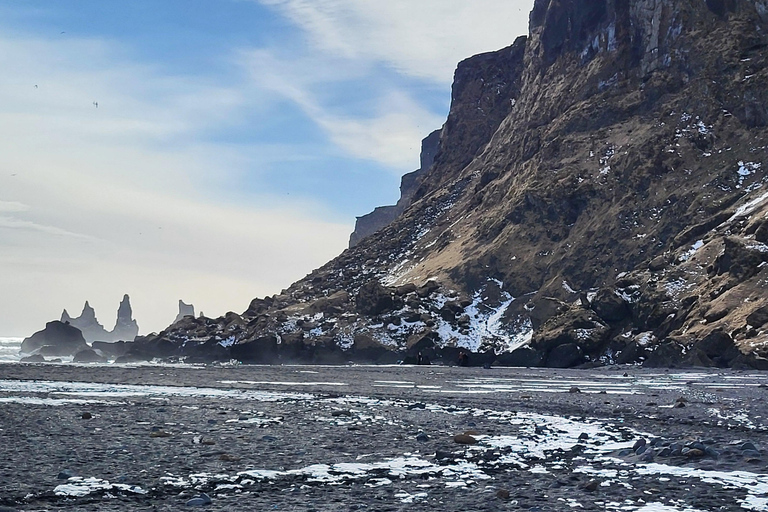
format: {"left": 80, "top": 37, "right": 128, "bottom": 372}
{"left": 0, "top": 0, "right": 533, "bottom": 336}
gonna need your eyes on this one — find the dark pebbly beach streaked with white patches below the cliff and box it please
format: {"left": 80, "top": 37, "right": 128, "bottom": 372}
{"left": 0, "top": 364, "right": 768, "bottom": 512}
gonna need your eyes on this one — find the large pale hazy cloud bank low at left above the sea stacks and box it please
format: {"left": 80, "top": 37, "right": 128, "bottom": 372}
{"left": 0, "top": 35, "right": 350, "bottom": 335}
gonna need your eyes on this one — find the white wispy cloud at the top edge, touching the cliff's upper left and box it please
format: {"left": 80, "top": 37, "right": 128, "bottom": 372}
{"left": 258, "top": 0, "right": 532, "bottom": 85}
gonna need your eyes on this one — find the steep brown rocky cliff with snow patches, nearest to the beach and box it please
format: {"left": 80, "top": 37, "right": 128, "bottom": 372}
{"left": 134, "top": 0, "right": 768, "bottom": 367}
